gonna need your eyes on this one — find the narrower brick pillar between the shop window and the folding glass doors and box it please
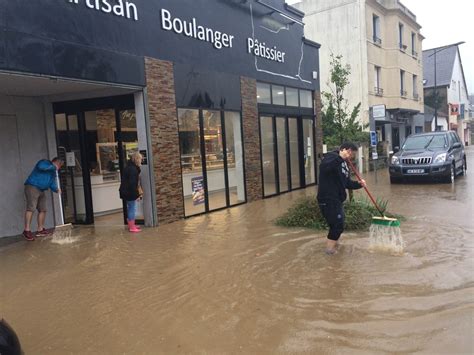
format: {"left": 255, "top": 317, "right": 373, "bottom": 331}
{"left": 240, "top": 77, "right": 263, "bottom": 202}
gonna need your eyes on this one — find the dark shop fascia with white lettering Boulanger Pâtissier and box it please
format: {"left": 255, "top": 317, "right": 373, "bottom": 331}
{"left": 6, "top": 0, "right": 320, "bottom": 90}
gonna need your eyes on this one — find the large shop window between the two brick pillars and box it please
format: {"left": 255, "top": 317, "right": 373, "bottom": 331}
{"left": 178, "top": 108, "right": 245, "bottom": 216}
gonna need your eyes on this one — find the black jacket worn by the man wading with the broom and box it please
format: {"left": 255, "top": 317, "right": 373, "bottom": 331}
{"left": 318, "top": 151, "right": 362, "bottom": 202}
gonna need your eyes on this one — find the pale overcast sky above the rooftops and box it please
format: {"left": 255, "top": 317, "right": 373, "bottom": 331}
{"left": 286, "top": 0, "right": 474, "bottom": 95}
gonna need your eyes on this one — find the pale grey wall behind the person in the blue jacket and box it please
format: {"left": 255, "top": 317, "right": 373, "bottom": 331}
{"left": 0, "top": 96, "right": 54, "bottom": 237}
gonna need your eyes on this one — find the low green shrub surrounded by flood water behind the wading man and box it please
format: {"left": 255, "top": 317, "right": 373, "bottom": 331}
{"left": 275, "top": 197, "right": 400, "bottom": 230}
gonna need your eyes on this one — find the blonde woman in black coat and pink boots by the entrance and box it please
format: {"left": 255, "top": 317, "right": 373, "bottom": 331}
{"left": 120, "top": 152, "right": 143, "bottom": 233}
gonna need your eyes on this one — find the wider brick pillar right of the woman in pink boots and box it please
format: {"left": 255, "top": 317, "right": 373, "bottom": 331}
{"left": 145, "top": 58, "right": 184, "bottom": 224}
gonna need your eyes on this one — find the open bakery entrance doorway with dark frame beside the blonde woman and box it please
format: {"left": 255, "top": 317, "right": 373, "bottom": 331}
{"left": 53, "top": 95, "right": 143, "bottom": 225}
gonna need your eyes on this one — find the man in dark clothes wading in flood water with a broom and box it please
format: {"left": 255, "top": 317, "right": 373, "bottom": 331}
{"left": 318, "top": 143, "right": 366, "bottom": 255}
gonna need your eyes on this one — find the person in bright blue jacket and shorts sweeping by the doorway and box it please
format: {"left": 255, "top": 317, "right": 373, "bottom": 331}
{"left": 23, "top": 158, "right": 64, "bottom": 241}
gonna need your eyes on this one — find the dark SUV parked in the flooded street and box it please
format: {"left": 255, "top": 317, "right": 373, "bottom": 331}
{"left": 389, "top": 131, "right": 467, "bottom": 183}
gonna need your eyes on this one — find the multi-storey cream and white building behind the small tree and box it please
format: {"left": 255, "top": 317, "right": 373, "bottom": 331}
{"left": 293, "top": 0, "right": 424, "bottom": 149}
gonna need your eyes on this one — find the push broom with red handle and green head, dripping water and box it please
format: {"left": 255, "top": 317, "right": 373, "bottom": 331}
{"left": 347, "top": 160, "right": 404, "bottom": 253}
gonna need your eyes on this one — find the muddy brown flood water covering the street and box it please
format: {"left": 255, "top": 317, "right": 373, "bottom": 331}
{"left": 0, "top": 147, "right": 474, "bottom": 354}
